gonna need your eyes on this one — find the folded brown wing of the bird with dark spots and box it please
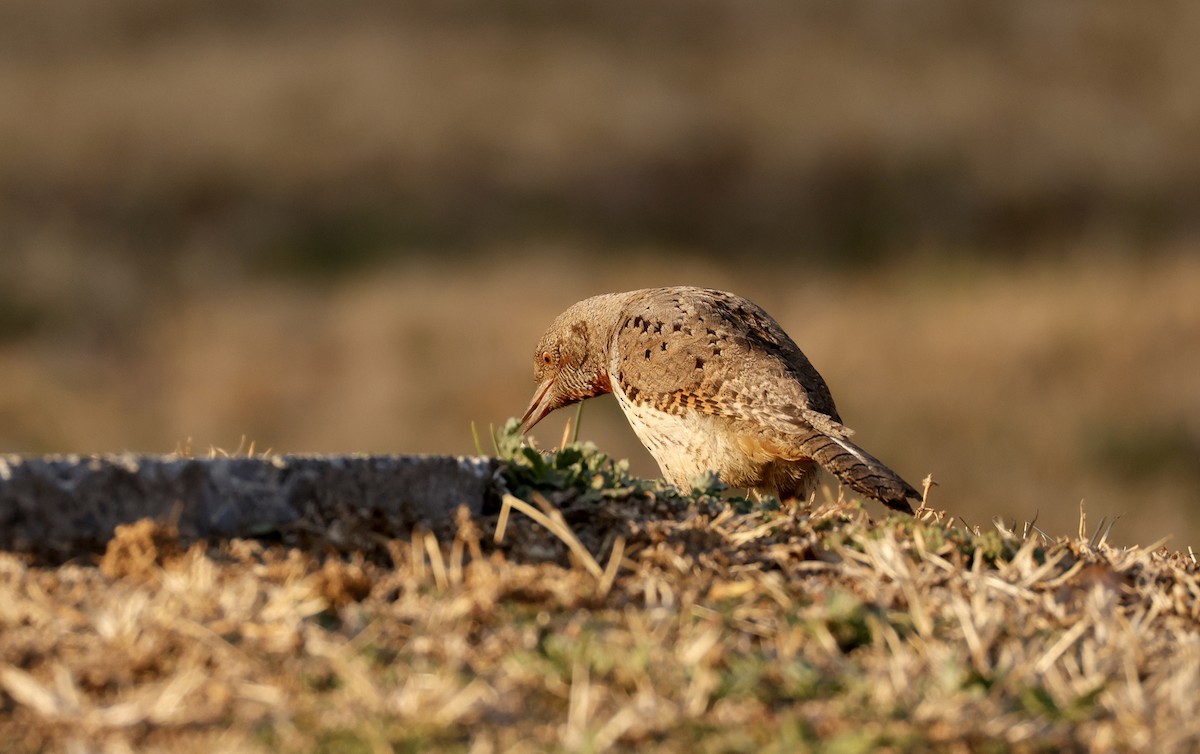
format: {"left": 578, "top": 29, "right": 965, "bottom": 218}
{"left": 610, "top": 288, "right": 851, "bottom": 438}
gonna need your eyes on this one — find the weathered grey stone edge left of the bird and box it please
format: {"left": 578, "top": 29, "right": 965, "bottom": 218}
{"left": 0, "top": 454, "right": 504, "bottom": 553}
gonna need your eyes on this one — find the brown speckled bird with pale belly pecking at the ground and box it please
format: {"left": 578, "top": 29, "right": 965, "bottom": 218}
{"left": 520, "top": 286, "right": 920, "bottom": 514}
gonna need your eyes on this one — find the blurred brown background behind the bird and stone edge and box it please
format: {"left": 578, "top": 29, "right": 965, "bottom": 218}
{"left": 0, "top": 0, "right": 1200, "bottom": 549}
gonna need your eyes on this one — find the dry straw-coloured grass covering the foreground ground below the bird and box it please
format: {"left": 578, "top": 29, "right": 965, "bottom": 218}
{"left": 0, "top": 436, "right": 1200, "bottom": 753}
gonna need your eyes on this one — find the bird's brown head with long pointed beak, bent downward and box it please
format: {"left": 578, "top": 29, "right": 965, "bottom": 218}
{"left": 521, "top": 297, "right": 616, "bottom": 432}
